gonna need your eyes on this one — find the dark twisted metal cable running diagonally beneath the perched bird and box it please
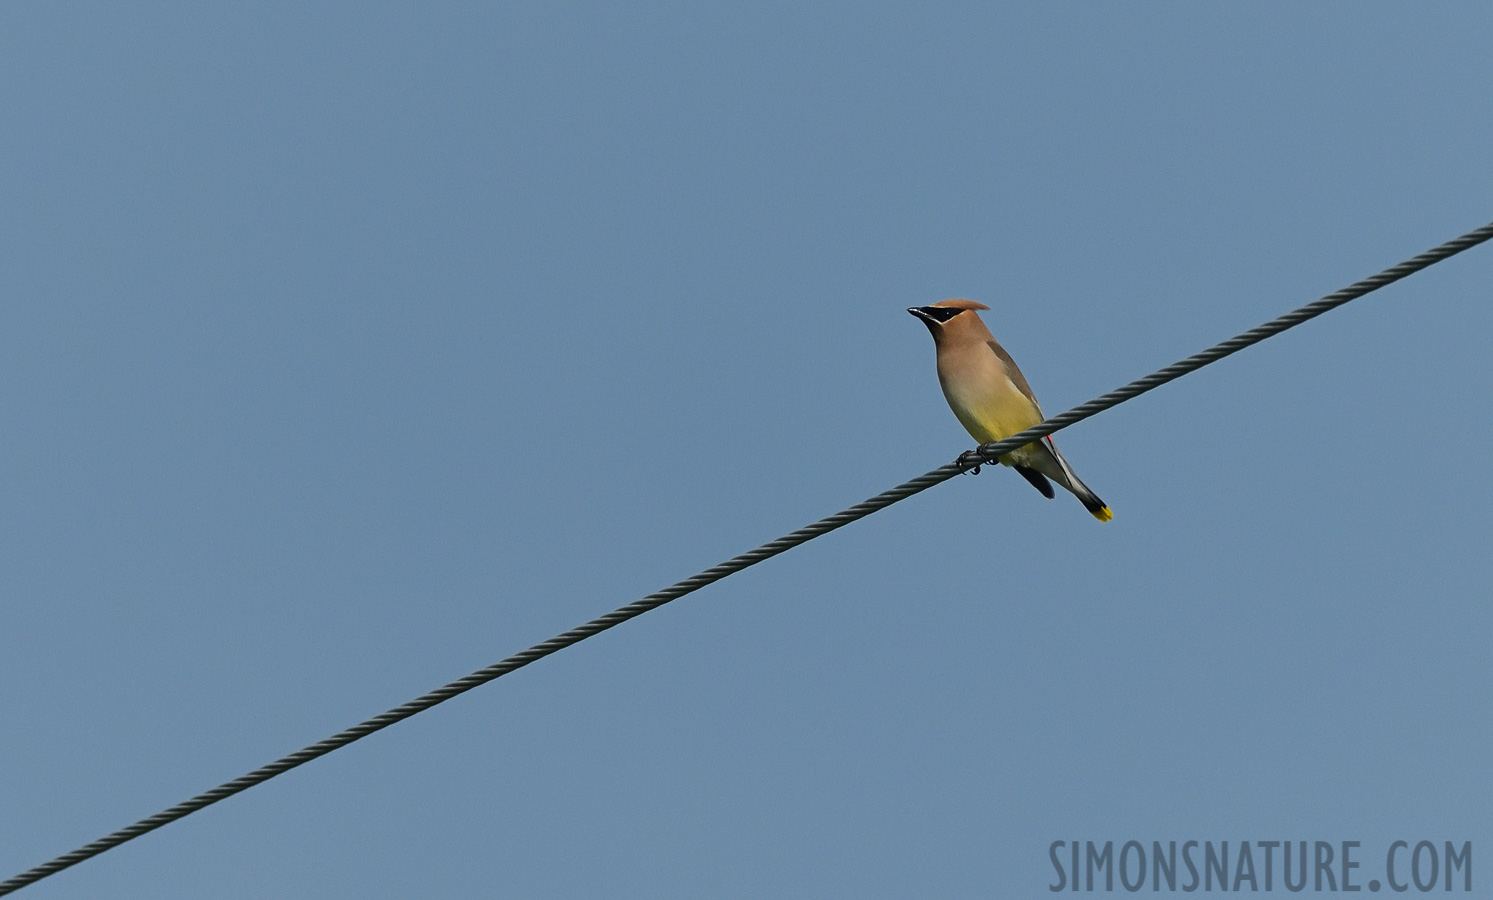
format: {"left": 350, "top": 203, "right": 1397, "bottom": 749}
{"left": 0, "top": 222, "right": 1493, "bottom": 896}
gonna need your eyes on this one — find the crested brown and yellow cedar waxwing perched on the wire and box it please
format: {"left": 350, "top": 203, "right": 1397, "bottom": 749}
{"left": 908, "top": 300, "right": 1114, "bottom": 522}
